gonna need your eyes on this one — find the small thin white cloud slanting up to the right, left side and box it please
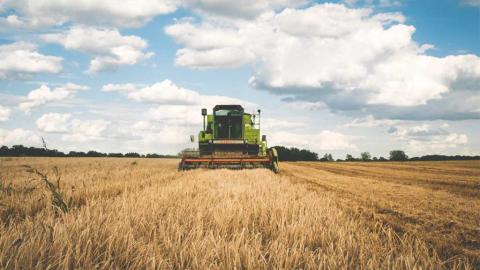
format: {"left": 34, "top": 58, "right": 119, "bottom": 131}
{"left": 18, "top": 83, "right": 89, "bottom": 113}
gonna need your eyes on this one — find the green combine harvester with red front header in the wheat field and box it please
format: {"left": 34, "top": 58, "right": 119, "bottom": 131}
{"left": 178, "top": 105, "right": 279, "bottom": 173}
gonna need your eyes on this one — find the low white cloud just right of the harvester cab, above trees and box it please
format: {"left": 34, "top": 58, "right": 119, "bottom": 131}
{"left": 267, "top": 130, "right": 357, "bottom": 152}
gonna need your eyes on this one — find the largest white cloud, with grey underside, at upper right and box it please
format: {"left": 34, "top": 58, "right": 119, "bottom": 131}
{"left": 165, "top": 3, "right": 480, "bottom": 118}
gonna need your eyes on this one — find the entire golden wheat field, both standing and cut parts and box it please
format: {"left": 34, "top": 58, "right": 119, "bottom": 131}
{"left": 0, "top": 158, "right": 480, "bottom": 269}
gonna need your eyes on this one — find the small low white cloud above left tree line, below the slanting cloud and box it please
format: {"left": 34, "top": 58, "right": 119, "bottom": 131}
{"left": 36, "top": 113, "right": 110, "bottom": 142}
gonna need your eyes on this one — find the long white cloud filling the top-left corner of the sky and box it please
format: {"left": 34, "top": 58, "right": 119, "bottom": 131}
{"left": 0, "top": 0, "right": 178, "bottom": 28}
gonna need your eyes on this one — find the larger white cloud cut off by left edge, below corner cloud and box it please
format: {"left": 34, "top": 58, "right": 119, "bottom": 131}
{"left": 0, "top": 42, "right": 62, "bottom": 80}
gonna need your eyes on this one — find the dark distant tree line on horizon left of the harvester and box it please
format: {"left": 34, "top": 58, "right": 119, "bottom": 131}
{"left": 0, "top": 145, "right": 176, "bottom": 158}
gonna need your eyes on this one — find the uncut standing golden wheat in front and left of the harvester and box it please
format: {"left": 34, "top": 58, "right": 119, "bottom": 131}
{"left": 0, "top": 159, "right": 471, "bottom": 269}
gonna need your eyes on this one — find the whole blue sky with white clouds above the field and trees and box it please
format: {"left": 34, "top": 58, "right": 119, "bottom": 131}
{"left": 0, "top": 0, "right": 480, "bottom": 158}
